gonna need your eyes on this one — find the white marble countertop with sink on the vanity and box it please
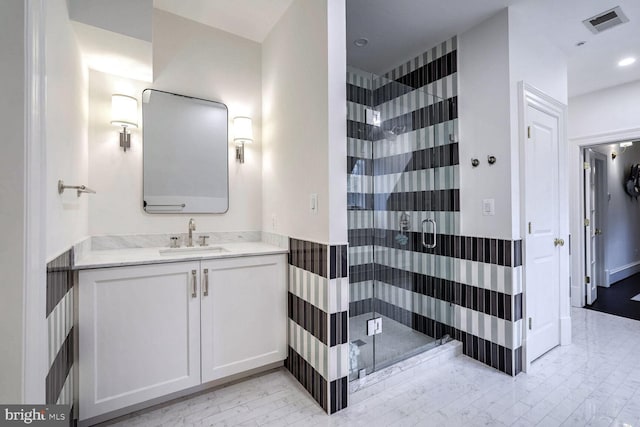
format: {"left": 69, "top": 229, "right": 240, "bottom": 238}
{"left": 74, "top": 242, "right": 288, "bottom": 270}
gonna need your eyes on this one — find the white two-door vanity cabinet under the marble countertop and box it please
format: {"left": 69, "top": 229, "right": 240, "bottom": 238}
{"left": 78, "top": 254, "right": 287, "bottom": 421}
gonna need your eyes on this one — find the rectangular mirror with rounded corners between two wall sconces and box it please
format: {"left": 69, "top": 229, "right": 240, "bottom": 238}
{"left": 142, "top": 89, "right": 229, "bottom": 214}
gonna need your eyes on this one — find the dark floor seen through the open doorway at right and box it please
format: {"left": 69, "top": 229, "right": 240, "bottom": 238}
{"left": 586, "top": 273, "right": 640, "bottom": 320}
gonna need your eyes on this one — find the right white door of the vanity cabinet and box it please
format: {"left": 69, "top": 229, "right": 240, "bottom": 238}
{"left": 201, "top": 255, "right": 287, "bottom": 382}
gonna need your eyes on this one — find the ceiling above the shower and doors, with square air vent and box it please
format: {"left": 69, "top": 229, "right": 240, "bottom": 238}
{"left": 346, "top": 0, "right": 640, "bottom": 96}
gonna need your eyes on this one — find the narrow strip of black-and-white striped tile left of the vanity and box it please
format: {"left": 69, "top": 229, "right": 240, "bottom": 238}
{"left": 45, "top": 249, "right": 75, "bottom": 405}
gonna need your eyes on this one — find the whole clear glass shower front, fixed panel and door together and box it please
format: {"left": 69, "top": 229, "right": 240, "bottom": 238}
{"left": 347, "top": 70, "right": 459, "bottom": 380}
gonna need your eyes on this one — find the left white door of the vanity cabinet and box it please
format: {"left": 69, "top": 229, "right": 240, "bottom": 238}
{"left": 78, "top": 262, "right": 200, "bottom": 420}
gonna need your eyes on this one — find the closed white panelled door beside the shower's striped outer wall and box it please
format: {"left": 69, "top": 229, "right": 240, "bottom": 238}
{"left": 525, "top": 105, "right": 564, "bottom": 361}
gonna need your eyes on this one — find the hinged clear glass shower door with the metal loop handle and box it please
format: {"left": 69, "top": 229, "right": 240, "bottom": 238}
{"left": 372, "top": 78, "right": 457, "bottom": 370}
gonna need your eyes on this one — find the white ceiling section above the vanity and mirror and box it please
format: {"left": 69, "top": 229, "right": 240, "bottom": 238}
{"left": 153, "top": 0, "right": 293, "bottom": 43}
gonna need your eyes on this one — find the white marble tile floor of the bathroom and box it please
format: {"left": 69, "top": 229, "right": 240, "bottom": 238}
{"left": 105, "top": 308, "right": 640, "bottom": 427}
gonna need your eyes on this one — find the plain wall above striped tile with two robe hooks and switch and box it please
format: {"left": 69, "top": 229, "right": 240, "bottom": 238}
{"left": 458, "top": 9, "right": 512, "bottom": 239}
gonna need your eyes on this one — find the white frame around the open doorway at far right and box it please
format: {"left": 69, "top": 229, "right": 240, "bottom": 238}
{"left": 569, "top": 128, "right": 640, "bottom": 307}
